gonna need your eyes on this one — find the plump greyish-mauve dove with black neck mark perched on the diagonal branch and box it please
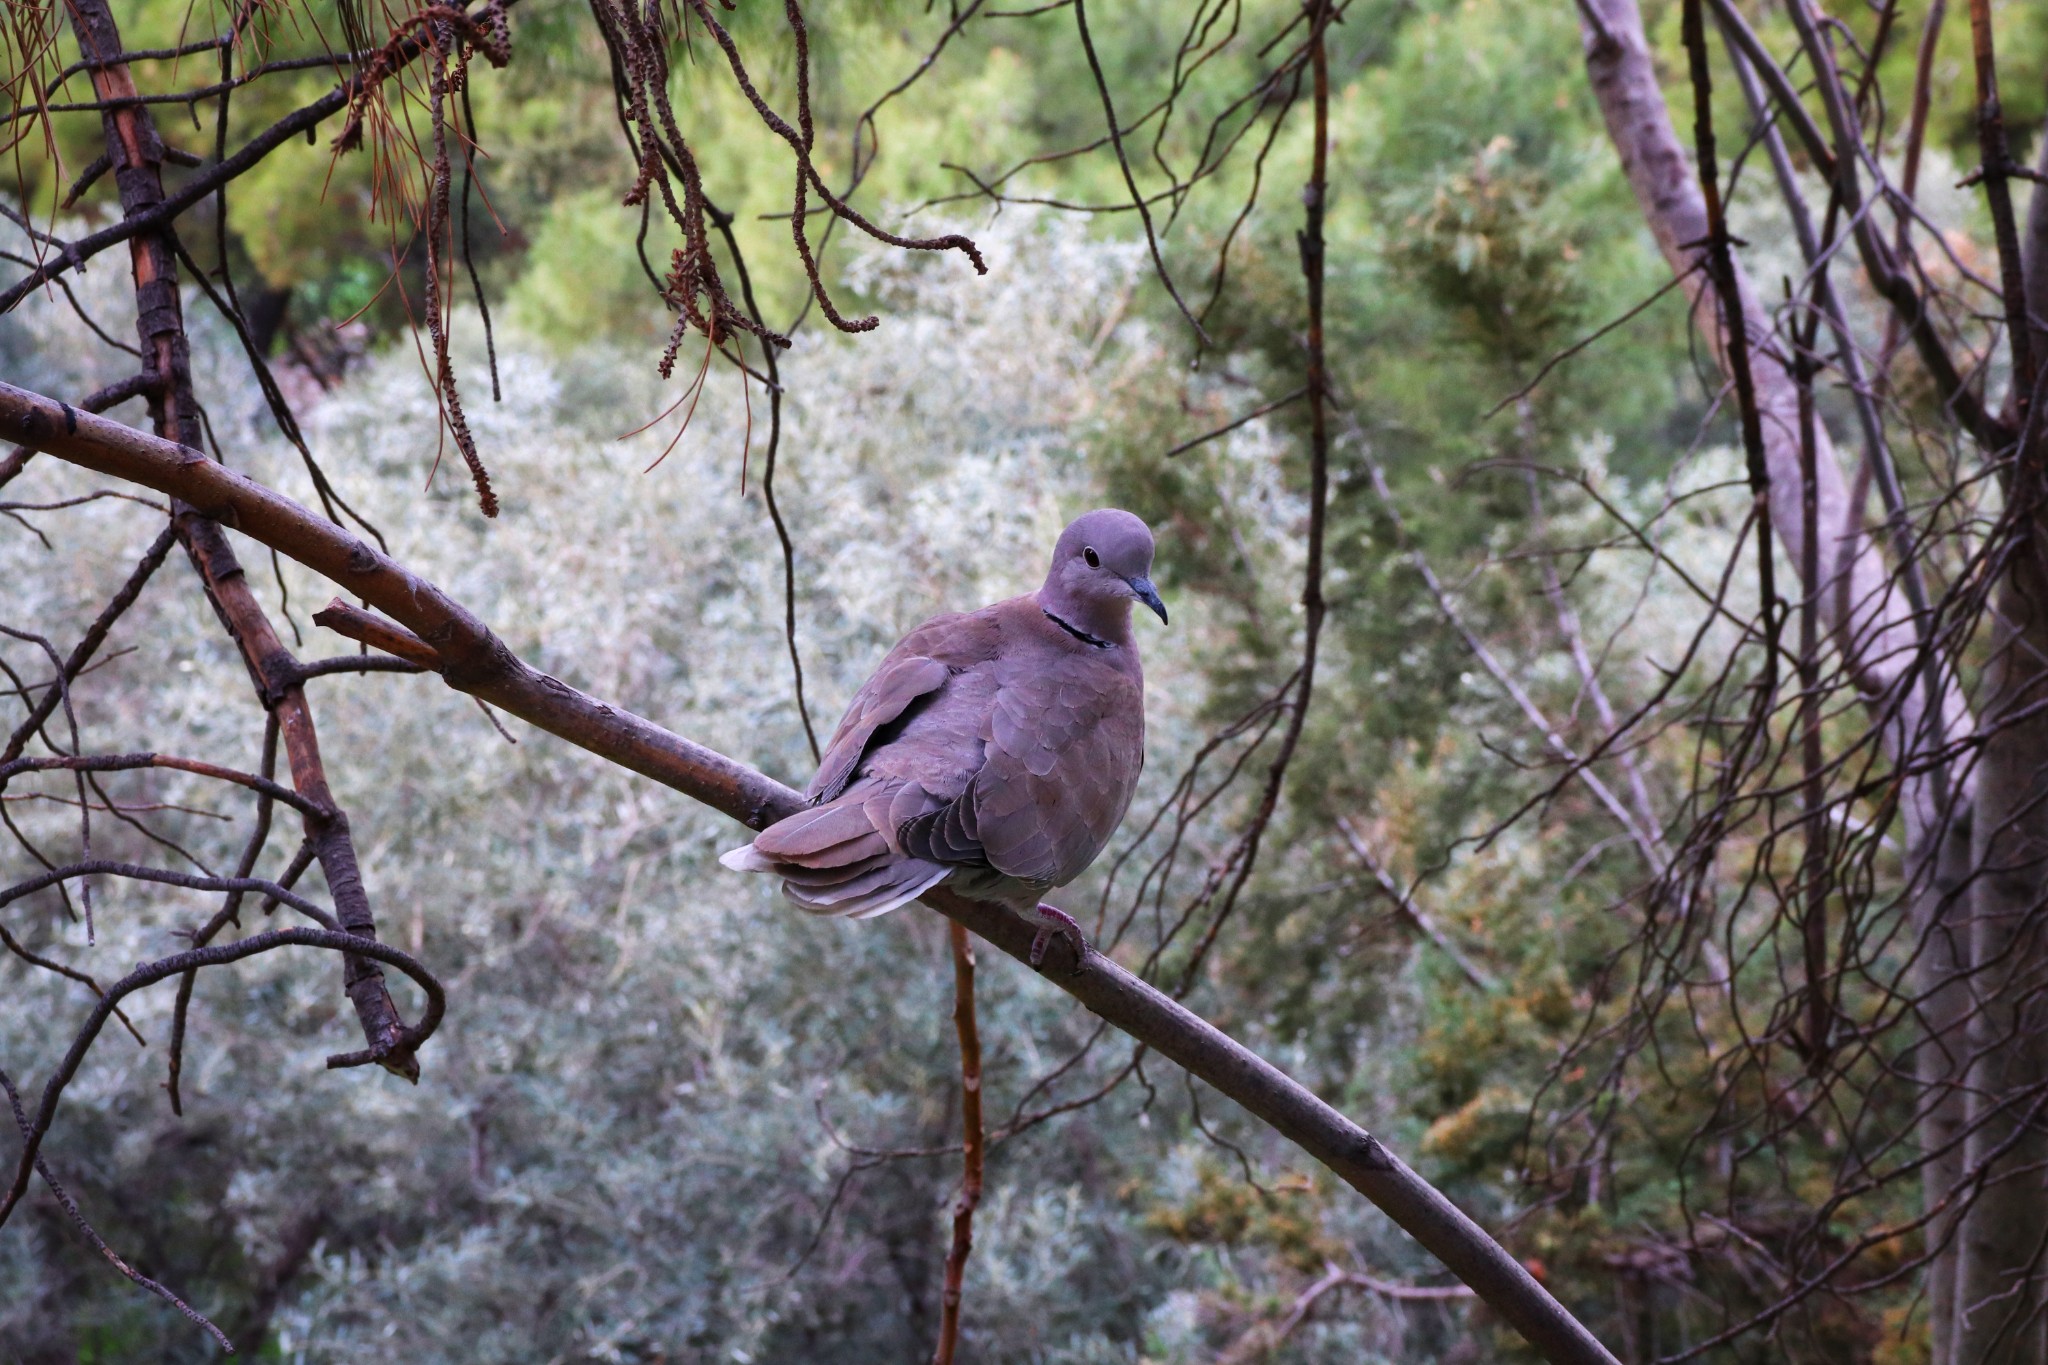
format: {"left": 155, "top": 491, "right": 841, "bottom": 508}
{"left": 719, "top": 508, "right": 1167, "bottom": 966}
